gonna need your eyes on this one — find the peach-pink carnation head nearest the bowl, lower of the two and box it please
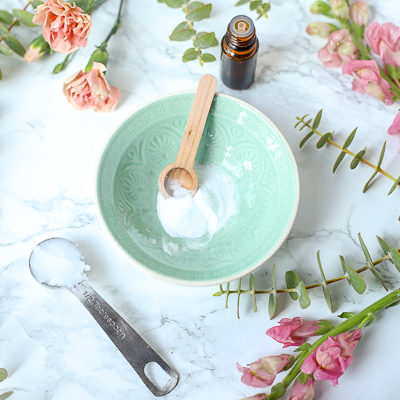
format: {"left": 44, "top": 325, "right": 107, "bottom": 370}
{"left": 63, "top": 62, "right": 120, "bottom": 111}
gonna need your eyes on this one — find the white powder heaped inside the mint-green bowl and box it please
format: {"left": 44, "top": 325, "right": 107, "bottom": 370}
{"left": 157, "top": 165, "right": 236, "bottom": 240}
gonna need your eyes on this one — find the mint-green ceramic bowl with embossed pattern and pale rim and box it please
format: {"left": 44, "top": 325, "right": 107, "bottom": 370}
{"left": 97, "top": 93, "right": 299, "bottom": 286}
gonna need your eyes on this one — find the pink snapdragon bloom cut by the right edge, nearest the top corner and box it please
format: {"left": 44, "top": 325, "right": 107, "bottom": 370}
{"left": 365, "top": 22, "right": 400, "bottom": 66}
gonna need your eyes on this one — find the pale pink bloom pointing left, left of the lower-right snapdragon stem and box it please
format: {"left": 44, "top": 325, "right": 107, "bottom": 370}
{"left": 236, "top": 354, "right": 290, "bottom": 387}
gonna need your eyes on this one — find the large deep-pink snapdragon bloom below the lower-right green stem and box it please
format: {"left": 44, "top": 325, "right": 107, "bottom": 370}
{"left": 301, "top": 329, "right": 361, "bottom": 385}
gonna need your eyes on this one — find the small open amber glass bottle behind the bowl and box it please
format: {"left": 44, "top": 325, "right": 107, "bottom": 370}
{"left": 221, "top": 15, "right": 258, "bottom": 90}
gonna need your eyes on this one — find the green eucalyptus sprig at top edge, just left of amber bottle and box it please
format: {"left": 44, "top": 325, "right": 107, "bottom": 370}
{"left": 157, "top": 0, "right": 218, "bottom": 65}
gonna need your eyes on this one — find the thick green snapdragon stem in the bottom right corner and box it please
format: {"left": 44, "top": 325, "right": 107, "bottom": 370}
{"left": 268, "top": 289, "right": 400, "bottom": 400}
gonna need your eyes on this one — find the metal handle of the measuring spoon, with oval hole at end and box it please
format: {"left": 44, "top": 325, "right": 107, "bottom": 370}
{"left": 71, "top": 281, "right": 179, "bottom": 396}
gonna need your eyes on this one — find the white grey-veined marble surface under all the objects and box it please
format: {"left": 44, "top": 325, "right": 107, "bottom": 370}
{"left": 0, "top": 0, "right": 400, "bottom": 400}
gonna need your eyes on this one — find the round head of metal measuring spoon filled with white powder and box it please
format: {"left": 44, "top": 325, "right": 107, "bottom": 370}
{"left": 29, "top": 238, "right": 90, "bottom": 288}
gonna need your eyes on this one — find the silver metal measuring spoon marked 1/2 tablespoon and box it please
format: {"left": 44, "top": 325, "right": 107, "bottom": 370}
{"left": 29, "top": 238, "right": 179, "bottom": 396}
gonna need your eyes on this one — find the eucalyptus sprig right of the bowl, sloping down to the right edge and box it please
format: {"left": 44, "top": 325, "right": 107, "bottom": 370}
{"left": 295, "top": 110, "right": 400, "bottom": 195}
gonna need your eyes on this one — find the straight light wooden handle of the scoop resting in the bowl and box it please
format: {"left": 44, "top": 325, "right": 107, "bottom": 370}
{"left": 175, "top": 75, "right": 217, "bottom": 170}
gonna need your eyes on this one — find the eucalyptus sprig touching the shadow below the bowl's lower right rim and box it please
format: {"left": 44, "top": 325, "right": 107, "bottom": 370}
{"left": 214, "top": 234, "right": 400, "bottom": 319}
